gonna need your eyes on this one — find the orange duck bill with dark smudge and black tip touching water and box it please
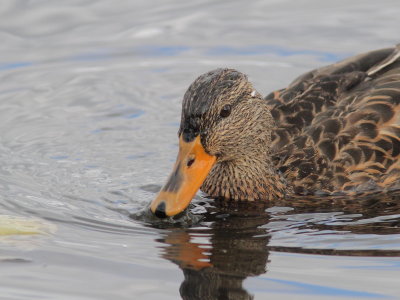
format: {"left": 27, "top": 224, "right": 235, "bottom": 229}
{"left": 150, "top": 136, "right": 216, "bottom": 218}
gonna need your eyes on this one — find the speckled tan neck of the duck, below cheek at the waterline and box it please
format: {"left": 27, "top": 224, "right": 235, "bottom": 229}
{"left": 201, "top": 151, "right": 287, "bottom": 201}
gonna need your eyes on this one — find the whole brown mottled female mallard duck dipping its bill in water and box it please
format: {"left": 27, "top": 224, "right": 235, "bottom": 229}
{"left": 151, "top": 46, "right": 400, "bottom": 217}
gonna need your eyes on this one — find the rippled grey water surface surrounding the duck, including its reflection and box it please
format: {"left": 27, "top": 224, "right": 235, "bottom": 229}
{"left": 0, "top": 0, "right": 400, "bottom": 299}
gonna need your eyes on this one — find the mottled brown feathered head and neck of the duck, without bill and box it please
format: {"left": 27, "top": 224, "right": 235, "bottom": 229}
{"left": 179, "top": 69, "right": 288, "bottom": 200}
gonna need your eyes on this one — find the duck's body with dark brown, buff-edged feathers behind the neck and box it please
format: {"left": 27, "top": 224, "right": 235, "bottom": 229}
{"left": 265, "top": 46, "right": 400, "bottom": 194}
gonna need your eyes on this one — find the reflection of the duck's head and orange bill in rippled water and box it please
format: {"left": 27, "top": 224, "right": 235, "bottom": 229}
{"left": 160, "top": 202, "right": 269, "bottom": 300}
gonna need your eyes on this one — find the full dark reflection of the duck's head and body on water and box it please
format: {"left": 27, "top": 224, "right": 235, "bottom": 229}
{"left": 151, "top": 195, "right": 400, "bottom": 300}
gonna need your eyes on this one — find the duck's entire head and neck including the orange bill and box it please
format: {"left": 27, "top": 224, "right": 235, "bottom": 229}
{"left": 150, "top": 69, "right": 282, "bottom": 217}
